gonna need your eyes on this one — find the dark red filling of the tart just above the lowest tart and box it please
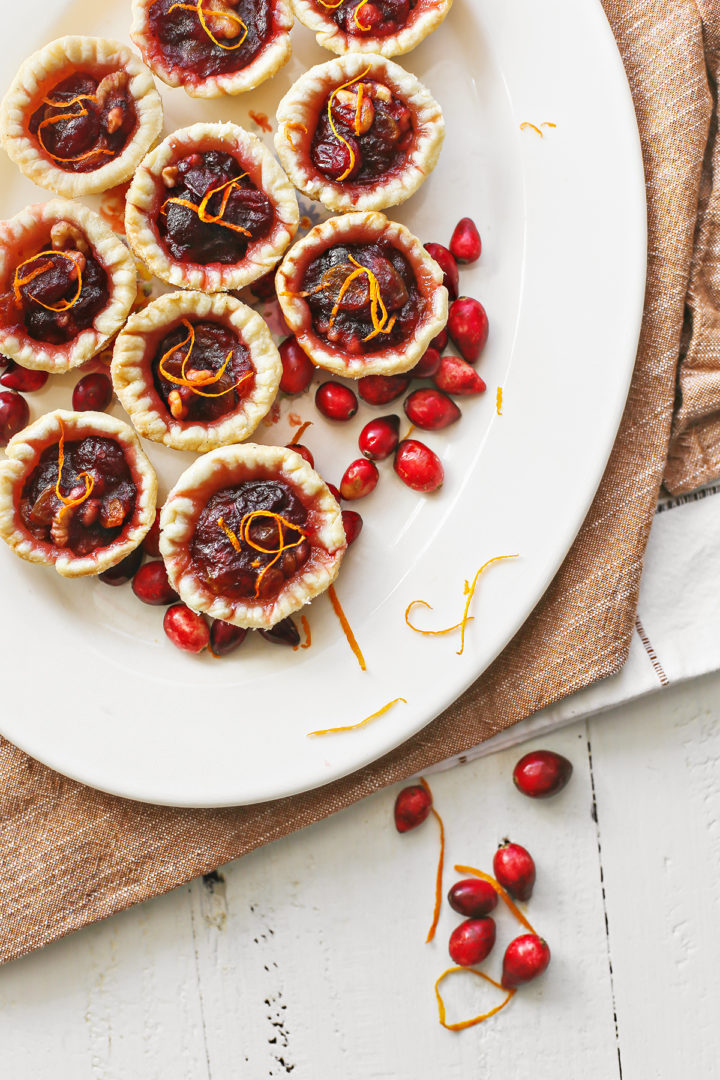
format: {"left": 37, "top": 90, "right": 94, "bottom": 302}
{"left": 152, "top": 323, "right": 255, "bottom": 423}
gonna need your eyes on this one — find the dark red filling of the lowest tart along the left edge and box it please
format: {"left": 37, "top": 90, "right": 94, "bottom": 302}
{"left": 19, "top": 435, "right": 137, "bottom": 555}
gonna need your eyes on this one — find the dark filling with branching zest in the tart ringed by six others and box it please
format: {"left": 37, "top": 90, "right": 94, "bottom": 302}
{"left": 158, "top": 150, "right": 275, "bottom": 266}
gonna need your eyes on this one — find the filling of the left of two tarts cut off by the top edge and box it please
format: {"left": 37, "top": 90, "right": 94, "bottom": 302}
{"left": 149, "top": 0, "right": 272, "bottom": 79}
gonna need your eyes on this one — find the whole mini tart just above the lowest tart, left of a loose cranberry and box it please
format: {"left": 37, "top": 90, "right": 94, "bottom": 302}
{"left": 111, "top": 293, "right": 283, "bottom": 451}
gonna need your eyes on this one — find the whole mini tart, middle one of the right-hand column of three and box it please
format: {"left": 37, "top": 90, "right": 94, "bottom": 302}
{"left": 275, "top": 53, "right": 445, "bottom": 211}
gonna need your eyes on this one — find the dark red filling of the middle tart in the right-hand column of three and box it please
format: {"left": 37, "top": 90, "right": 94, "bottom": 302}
{"left": 310, "top": 82, "right": 415, "bottom": 184}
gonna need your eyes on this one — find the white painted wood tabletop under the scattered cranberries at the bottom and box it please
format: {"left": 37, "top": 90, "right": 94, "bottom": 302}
{"left": 0, "top": 675, "right": 720, "bottom": 1080}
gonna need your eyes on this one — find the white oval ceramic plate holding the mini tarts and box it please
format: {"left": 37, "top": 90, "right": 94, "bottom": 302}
{"left": 0, "top": 0, "right": 646, "bottom": 806}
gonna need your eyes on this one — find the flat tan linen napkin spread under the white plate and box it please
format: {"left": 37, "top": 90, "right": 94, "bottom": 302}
{"left": 0, "top": 0, "right": 719, "bottom": 961}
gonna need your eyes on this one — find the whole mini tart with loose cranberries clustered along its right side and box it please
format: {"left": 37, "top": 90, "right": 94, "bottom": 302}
{"left": 275, "top": 212, "right": 448, "bottom": 379}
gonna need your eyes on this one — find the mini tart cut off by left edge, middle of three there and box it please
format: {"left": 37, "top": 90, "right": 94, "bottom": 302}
{"left": 0, "top": 199, "right": 137, "bottom": 373}
